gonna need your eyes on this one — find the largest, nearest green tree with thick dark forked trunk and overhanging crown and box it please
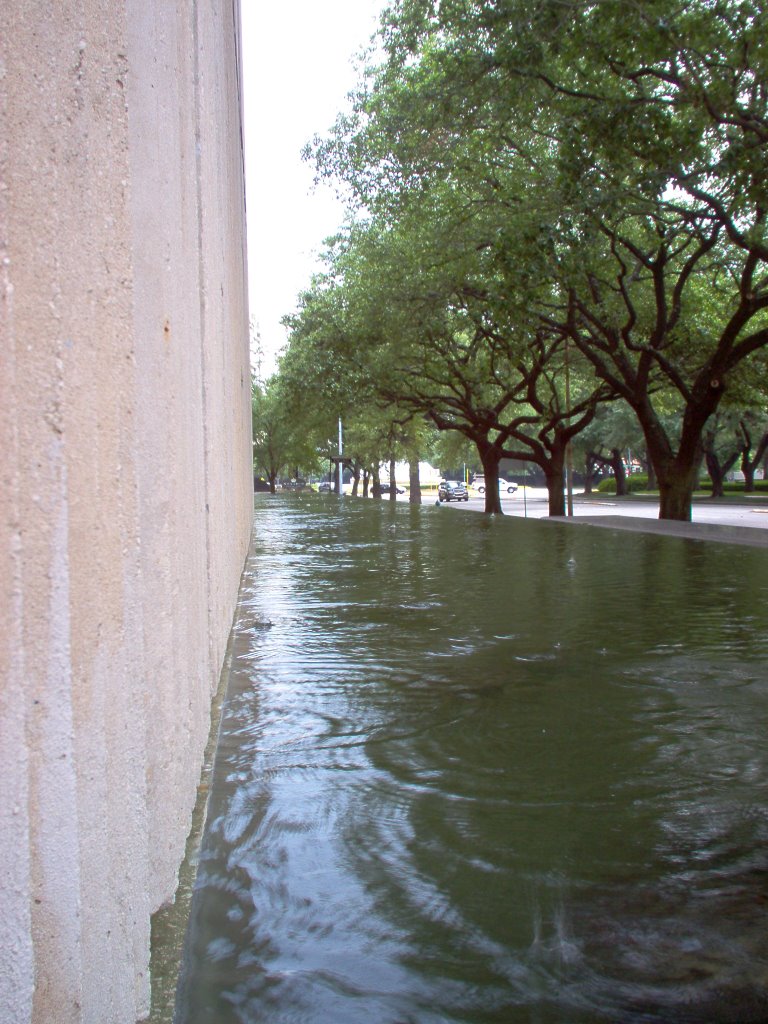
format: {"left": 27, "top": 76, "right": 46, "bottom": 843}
{"left": 314, "top": 0, "right": 768, "bottom": 519}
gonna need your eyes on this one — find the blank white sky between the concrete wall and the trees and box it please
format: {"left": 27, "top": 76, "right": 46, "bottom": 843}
{"left": 242, "top": 0, "right": 385, "bottom": 376}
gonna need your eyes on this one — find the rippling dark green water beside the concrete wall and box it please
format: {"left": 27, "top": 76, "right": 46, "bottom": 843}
{"left": 176, "top": 496, "right": 768, "bottom": 1024}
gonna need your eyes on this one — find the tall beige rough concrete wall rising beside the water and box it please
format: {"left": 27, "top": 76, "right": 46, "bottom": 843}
{"left": 0, "top": 0, "right": 252, "bottom": 1024}
